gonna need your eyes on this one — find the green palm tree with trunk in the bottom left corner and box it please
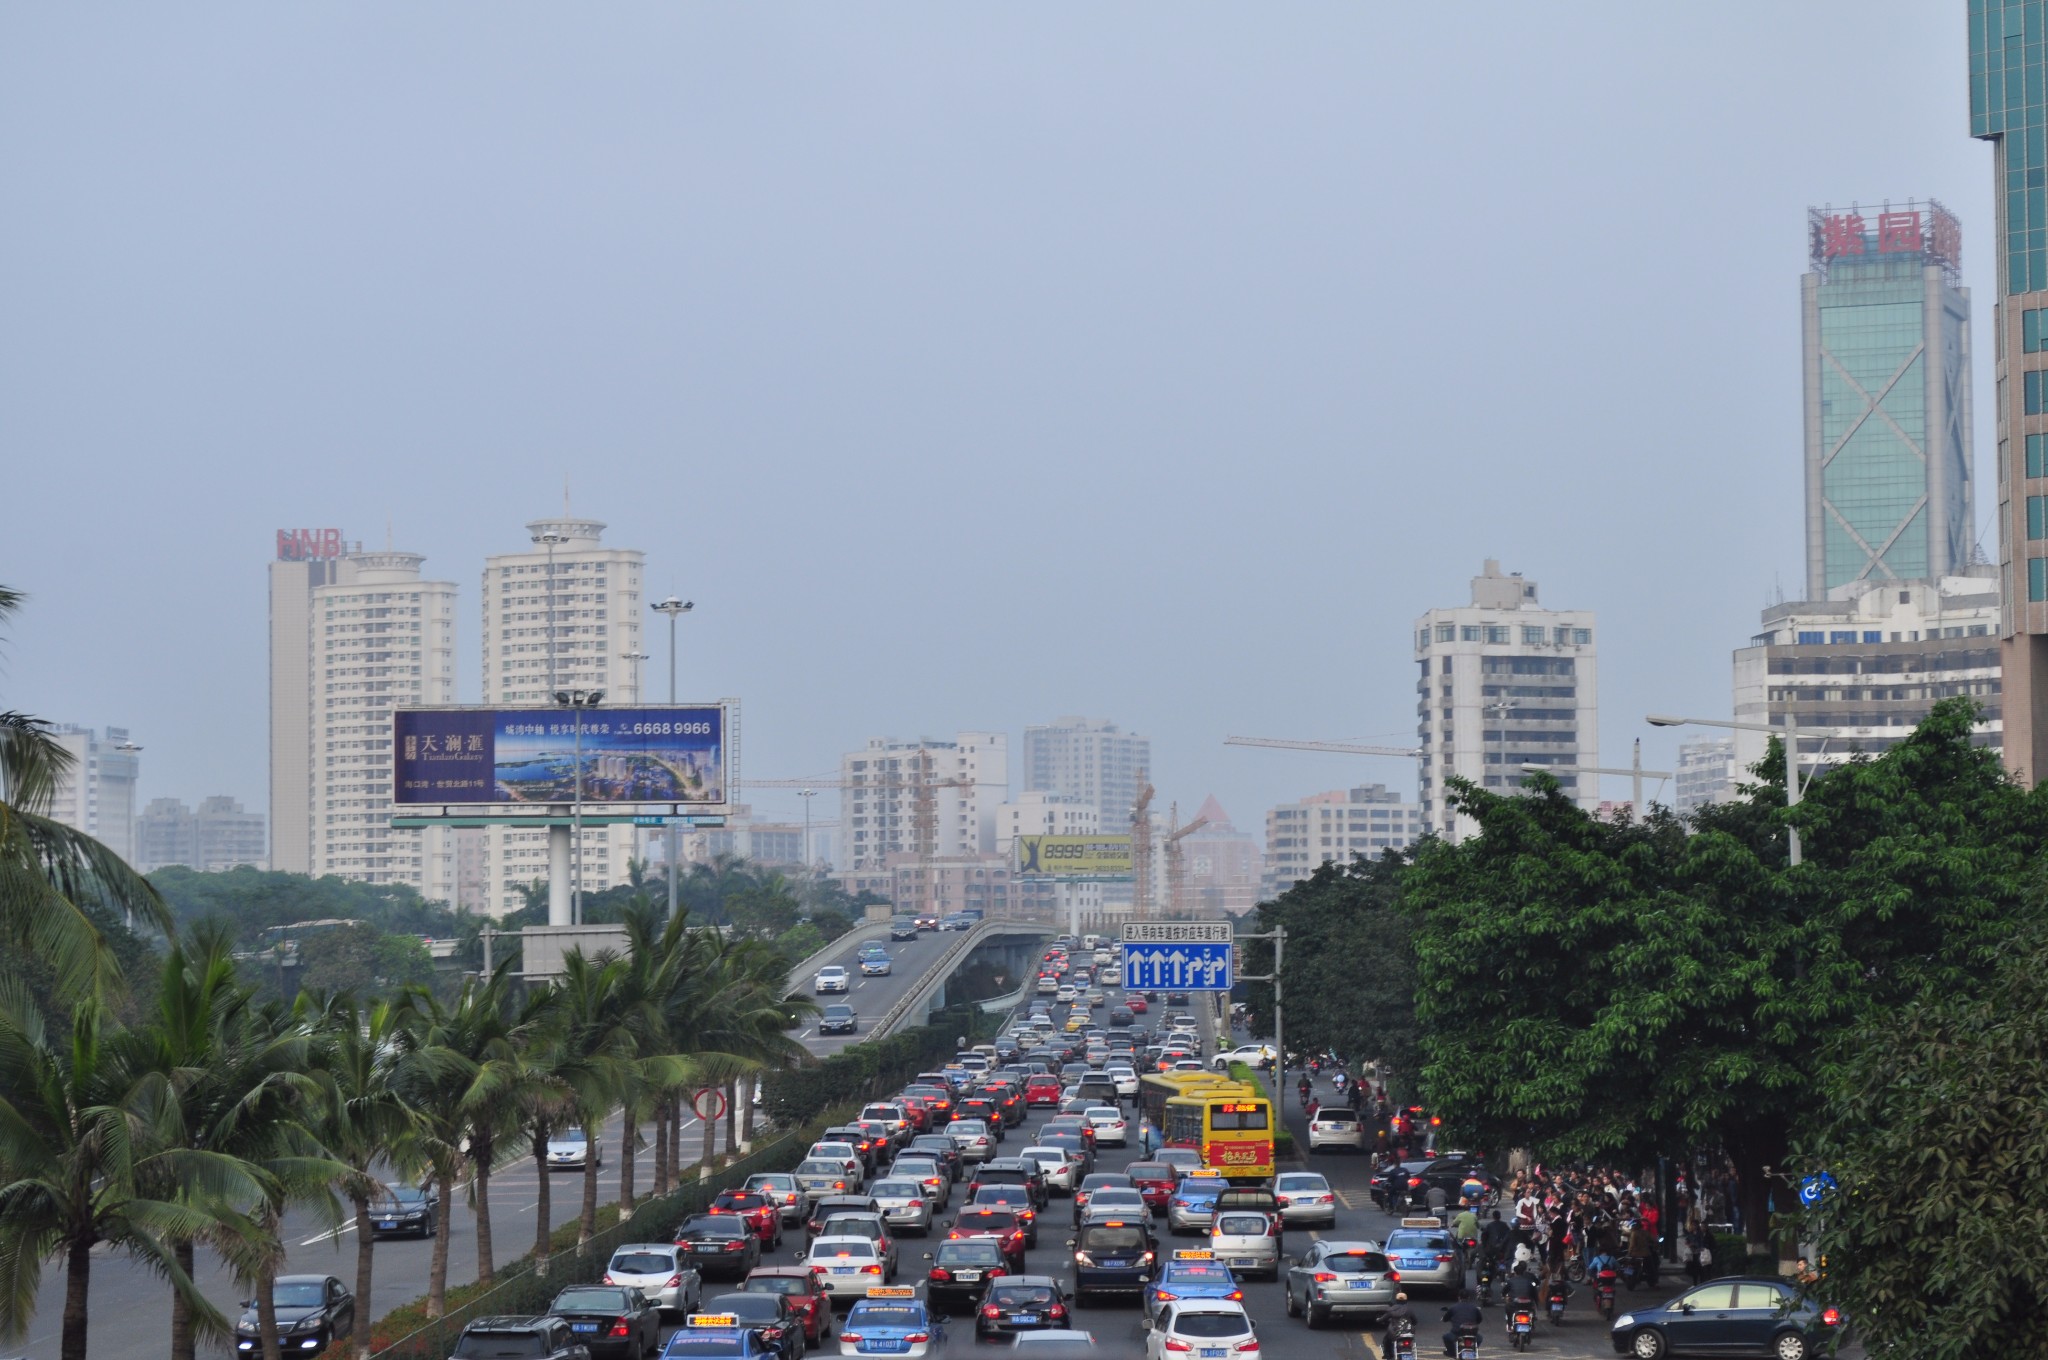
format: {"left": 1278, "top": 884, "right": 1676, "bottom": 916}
{"left": 0, "top": 989, "right": 274, "bottom": 1360}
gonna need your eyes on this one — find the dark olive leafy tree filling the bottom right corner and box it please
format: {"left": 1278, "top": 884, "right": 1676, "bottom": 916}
{"left": 1796, "top": 926, "right": 2048, "bottom": 1360}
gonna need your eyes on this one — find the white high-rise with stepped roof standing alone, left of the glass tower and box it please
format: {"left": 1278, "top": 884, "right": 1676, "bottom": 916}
{"left": 1415, "top": 559, "right": 1599, "bottom": 840}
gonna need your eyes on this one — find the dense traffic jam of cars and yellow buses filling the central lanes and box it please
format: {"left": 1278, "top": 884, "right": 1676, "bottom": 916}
{"left": 457, "top": 938, "right": 1839, "bottom": 1360}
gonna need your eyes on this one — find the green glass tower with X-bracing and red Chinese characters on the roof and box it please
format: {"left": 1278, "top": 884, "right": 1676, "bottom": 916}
{"left": 1800, "top": 199, "right": 1976, "bottom": 600}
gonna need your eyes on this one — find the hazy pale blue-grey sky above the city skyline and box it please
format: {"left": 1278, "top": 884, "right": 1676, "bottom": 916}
{"left": 0, "top": 0, "right": 1997, "bottom": 830}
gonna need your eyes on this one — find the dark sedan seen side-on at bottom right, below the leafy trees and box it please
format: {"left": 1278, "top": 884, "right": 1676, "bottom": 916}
{"left": 1612, "top": 1276, "right": 1843, "bottom": 1360}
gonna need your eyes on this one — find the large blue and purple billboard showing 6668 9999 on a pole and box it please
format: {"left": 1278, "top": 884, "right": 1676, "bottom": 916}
{"left": 391, "top": 705, "right": 729, "bottom": 807}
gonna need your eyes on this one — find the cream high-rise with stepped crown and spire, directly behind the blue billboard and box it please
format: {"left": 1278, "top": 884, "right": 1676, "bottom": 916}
{"left": 481, "top": 514, "right": 647, "bottom": 916}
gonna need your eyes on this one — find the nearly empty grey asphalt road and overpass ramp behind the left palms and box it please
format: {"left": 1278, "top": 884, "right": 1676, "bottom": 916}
{"left": 8, "top": 934, "right": 952, "bottom": 1360}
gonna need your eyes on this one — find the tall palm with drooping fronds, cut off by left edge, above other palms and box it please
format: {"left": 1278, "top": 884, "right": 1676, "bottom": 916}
{"left": 0, "top": 586, "right": 170, "bottom": 995}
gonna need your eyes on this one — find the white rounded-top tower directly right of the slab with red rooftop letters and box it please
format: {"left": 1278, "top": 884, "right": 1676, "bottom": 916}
{"left": 307, "top": 549, "right": 455, "bottom": 901}
